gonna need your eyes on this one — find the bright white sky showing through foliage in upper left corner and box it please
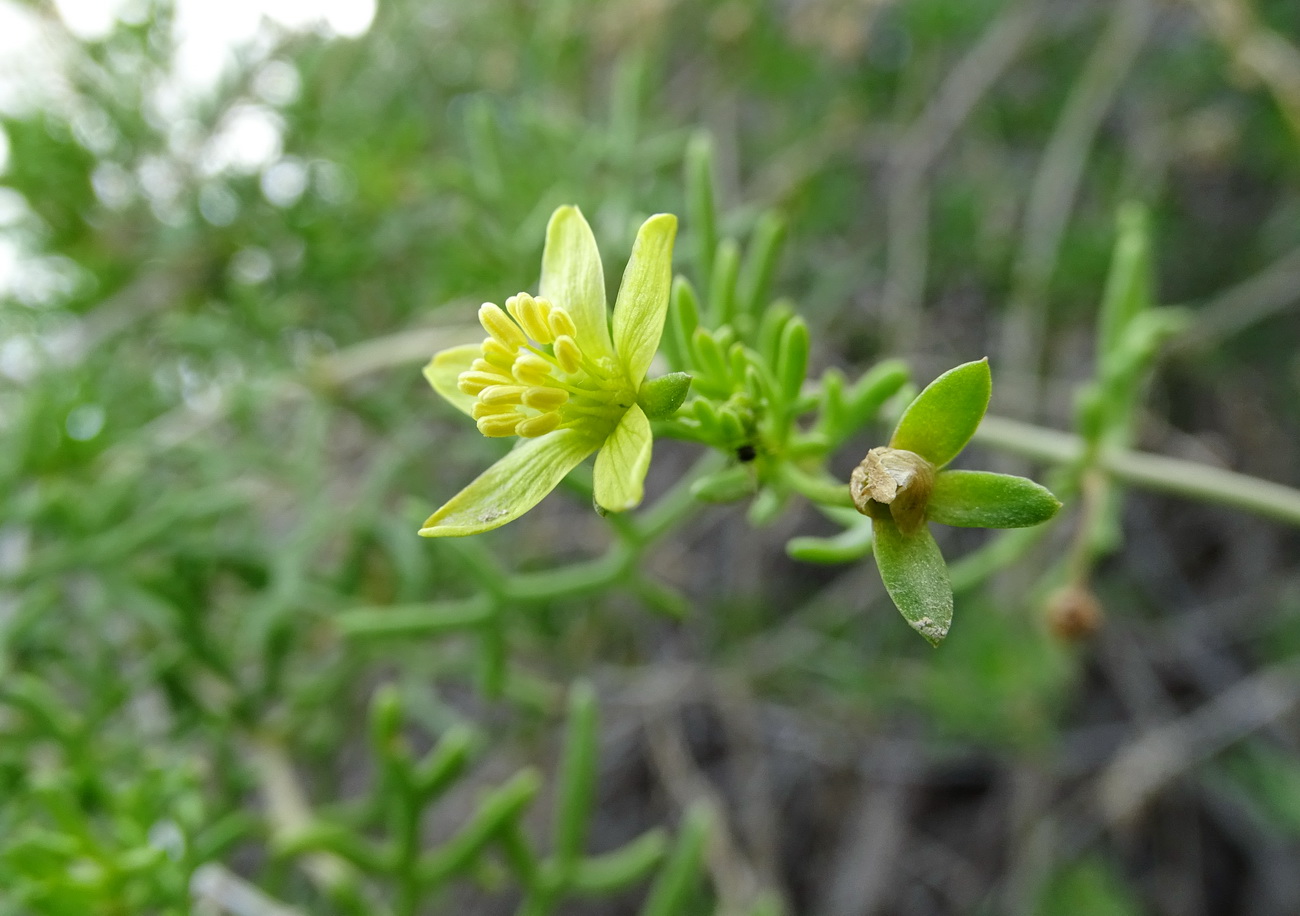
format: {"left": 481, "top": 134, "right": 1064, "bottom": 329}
{"left": 0, "top": 0, "right": 377, "bottom": 305}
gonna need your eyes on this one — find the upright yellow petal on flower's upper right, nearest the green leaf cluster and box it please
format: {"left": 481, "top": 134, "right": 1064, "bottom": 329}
{"left": 614, "top": 213, "right": 677, "bottom": 385}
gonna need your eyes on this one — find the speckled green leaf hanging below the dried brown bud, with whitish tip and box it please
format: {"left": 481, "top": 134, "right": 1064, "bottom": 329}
{"left": 871, "top": 518, "right": 953, "bottom": 646}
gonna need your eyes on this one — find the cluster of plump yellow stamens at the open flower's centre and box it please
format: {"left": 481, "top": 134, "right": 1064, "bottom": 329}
{"left": 456, "top": 292, "right": 636, "bottom": 438}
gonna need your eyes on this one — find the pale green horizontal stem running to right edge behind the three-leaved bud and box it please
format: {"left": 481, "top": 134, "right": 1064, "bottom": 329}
{"left": 975, "top": 417, "right": 1300, "bottom": 525}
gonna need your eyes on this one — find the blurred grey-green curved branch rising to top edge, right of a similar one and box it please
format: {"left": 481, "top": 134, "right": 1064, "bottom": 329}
{"left": 1000, "top": 0, "right": 1156, "bottom": 414}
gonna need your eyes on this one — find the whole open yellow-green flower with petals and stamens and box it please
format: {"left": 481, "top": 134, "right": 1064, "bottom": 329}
{"left": 420, "top": 207, "right": 677, "bottom": 538}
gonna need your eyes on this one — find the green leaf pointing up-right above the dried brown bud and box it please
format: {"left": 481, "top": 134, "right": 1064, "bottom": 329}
{"left": 889, "top": 357, "right": 993, "bottom": 468}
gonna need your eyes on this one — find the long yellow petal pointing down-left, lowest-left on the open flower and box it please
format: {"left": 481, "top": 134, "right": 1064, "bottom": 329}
{"left": 420, "top": 429, "right": 599, "bottom": 538}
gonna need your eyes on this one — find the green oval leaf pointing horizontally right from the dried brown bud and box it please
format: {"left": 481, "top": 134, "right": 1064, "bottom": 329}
{"left": 926, "top": 470, "right": 1061, "bottom": 528}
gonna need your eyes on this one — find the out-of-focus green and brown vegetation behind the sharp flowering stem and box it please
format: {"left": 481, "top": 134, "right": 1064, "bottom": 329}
{"left": 0, "top": 0, "right": 1300, "bottom": 916}
